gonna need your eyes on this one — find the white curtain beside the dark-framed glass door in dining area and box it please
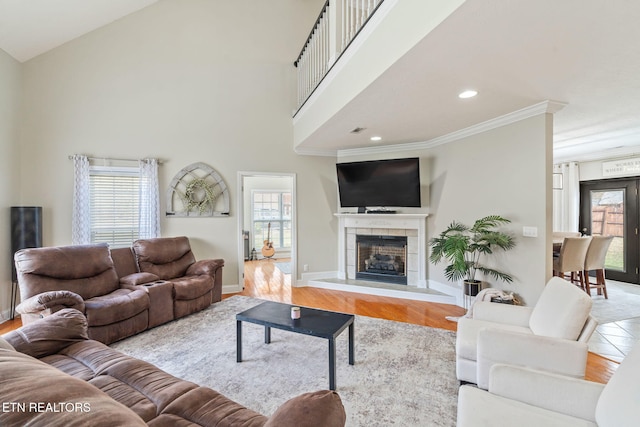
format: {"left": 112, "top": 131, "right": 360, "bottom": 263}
{"left": 553, "top": 162, "right": 580, "bottom": 231}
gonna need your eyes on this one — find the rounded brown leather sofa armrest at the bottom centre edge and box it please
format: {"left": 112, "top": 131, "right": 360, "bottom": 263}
{"left": 264, "top": 390, "right": 347, "bottom": 427}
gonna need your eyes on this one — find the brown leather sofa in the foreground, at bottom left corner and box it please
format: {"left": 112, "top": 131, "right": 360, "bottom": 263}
{"left": 0, "top": 309, "right": 346, "bottom": 427}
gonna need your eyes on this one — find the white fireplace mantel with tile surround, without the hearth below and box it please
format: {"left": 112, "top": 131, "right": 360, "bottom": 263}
{"left": 335, "top": 213, "right": 429, "bottom": 288}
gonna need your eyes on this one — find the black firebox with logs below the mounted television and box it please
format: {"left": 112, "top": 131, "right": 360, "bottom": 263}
{"left": 356, "top": 234, "right": 407, "bottom": 285}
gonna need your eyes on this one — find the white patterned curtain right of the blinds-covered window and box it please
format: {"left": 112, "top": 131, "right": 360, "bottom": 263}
{"left": 138, "top": 159, "right": 160, "bottom": 239}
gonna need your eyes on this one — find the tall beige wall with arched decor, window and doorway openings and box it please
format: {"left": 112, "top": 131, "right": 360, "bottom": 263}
{"left": 16, "top": 0, "right": 336, "bottom": 290}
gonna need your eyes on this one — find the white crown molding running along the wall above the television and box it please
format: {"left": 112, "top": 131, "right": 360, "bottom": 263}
{"left": 337, "top": 100, "right": 567, "bottom": 157}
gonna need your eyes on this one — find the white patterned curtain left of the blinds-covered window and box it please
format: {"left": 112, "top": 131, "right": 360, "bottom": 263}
{"left": 71, "top": 154, "right": 91, "bottom": 245}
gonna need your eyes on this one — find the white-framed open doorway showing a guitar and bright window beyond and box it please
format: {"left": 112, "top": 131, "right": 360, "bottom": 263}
{"left": 238, "top": 172, "right": 297, "bottom": 292}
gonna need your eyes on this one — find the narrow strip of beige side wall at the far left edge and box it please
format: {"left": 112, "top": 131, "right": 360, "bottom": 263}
{"left": 0, "top": 49, "right": 22, "bottom": 320}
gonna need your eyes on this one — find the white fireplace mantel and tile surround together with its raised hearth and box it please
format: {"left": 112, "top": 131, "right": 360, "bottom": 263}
{"left": 307, "top": 213, "right": 455, "bottom": 303}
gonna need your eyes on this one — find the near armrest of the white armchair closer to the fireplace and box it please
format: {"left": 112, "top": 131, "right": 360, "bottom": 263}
{"left": 477, "top": 328, "right": 588, "bottom": 389}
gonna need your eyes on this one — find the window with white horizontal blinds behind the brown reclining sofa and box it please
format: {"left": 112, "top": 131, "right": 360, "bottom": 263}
{"left": 89, "top": 166, "right": 140, "bottom": 248}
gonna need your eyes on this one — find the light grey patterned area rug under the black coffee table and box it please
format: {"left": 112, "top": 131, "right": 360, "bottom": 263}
{"left": 111, "top": 296, "right": 458, "bottom": 427}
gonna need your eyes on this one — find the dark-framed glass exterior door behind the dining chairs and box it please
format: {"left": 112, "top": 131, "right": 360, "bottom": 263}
{"left": 580, "top": 178, "right": 640, "bottom": 284}
